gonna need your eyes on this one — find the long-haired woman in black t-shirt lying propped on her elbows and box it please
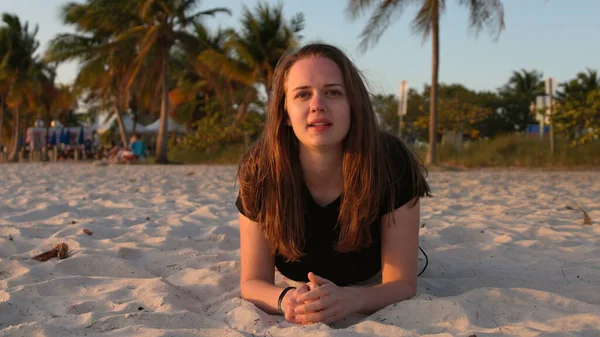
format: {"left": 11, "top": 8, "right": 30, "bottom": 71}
{"left": 236, "top": 44, "right": 430, "bottom": 323}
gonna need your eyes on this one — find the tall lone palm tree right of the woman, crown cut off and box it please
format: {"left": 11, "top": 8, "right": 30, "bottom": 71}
{"left": 347, "top": 0, "right": 504, "bottom": 164}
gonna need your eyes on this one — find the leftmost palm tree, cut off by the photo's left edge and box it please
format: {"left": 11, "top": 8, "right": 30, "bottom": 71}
{"left": 0, "top": 13, "right": 43, "bottom": 161}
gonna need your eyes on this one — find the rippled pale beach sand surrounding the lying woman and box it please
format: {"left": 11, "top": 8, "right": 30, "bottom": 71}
{"left": 0, "top": 164, "right": 600, "bottom": 337}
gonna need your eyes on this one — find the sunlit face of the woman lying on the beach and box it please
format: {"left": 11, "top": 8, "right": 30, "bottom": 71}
{"left": 285, "top": 57, "right": 350, "bottom": 149}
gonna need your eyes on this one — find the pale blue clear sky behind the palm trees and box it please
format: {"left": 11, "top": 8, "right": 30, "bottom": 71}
{"left": 0, "top": 0, "right": 600, "bottom": 94}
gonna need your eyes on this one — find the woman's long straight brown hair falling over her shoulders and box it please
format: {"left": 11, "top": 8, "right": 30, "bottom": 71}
{"left": 238, "top": 44, "right": 430, "bottom": 261}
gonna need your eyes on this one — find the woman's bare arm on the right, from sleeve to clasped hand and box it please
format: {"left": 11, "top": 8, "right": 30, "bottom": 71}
{"left": 296, "top": 198, "right": 420, "bottom": 323}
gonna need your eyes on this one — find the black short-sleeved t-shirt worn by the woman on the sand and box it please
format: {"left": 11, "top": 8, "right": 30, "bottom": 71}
{"left": 236, "top": 136, "right": 415, "bottom": 286}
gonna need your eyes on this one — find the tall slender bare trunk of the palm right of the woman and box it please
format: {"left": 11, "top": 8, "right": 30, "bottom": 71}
{"left": 425, "top": 1, "right": 440, "bottom": 165}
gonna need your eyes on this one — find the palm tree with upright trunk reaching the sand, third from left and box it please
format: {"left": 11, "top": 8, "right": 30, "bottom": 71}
{"left": 113, "top": 0, "right": 231, "bottom": 163}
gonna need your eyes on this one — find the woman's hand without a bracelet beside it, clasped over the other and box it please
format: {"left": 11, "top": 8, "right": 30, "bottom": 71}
{"left": 295, "top": 273, "right": 362, "bottom": 324}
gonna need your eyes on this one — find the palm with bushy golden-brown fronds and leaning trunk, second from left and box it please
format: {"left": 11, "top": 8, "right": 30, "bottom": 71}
{"left": 46, "top": 0, "right": 141, "bottom": 146}
